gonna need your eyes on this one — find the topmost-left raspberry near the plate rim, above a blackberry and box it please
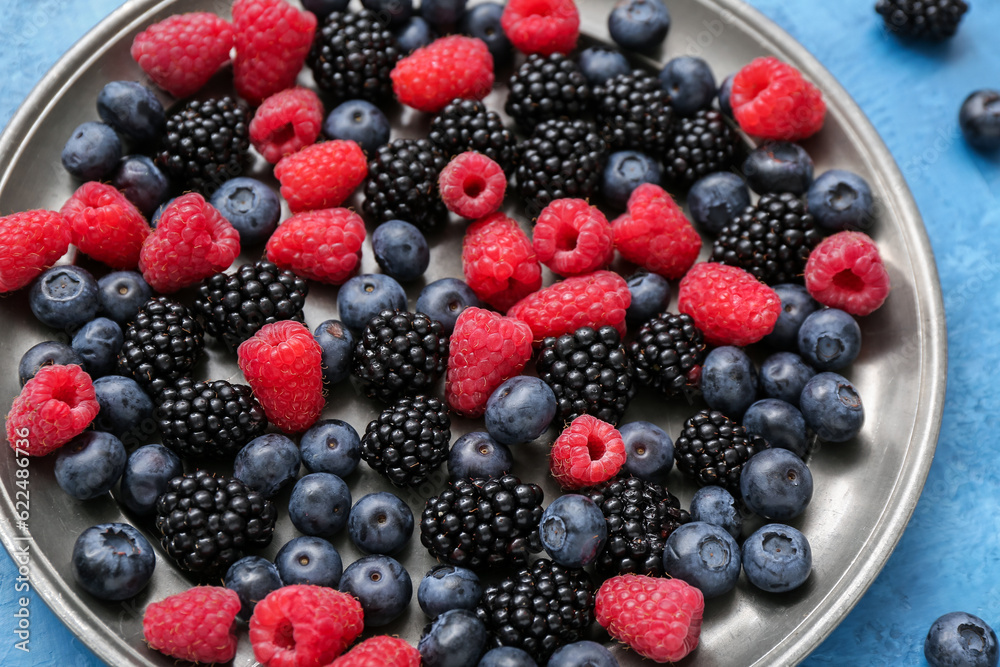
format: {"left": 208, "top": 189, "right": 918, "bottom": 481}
{"left": 132, "top": 12, "right": 235, "bottom": 98}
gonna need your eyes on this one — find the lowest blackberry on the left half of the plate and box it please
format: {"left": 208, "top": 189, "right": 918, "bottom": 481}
{"left": 156, "top": 470, "right": 277, "bottom": 579}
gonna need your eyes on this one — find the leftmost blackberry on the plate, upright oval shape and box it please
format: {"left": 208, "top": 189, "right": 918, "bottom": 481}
{"left": 118, "top": 296, "right": 205, "bottom": 395}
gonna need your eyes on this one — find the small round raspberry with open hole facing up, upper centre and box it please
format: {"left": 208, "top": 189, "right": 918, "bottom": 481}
{"left": 438, "top": 151, "right": 507, "bottom": 220}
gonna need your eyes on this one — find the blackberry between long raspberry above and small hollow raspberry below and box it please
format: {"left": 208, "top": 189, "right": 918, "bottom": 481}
{"left": 537, "top": 326, "right": 635, "bottom": 425}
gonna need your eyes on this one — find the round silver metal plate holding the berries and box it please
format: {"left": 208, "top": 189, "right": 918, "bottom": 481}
{"left": 0, "top": 0, "right": 946, "bottom": 667}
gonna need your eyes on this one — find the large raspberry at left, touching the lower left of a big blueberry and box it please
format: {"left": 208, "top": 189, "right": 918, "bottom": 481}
{"left": 139, "top": 192, "right": 240, "bottom": 294}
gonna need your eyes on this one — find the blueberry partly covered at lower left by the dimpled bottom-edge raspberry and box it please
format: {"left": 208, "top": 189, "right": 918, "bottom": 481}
{"left": 340, "top": 555, "right": 413, "bottom": 628}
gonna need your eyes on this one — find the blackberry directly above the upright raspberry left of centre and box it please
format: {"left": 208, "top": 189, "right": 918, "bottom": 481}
{"left": 194, "top": 260, "right": 309, "bottom": 349}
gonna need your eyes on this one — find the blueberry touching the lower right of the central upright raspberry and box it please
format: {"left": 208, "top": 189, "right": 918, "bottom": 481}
{"left": 484, "top": 375, "right": 556, "bottom": 445}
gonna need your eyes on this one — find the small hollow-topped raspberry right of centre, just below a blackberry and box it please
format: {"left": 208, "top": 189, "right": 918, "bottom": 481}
{"left": 549, "top": 415, "right": 625, "bottom": 490}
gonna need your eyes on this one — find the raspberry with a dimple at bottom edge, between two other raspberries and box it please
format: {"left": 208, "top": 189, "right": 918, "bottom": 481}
{"left": 250, "top": 584, "right": 364, "bottom": 667}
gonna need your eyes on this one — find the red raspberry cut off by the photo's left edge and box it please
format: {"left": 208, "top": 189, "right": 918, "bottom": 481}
{"left": 0, "top": 210, "right": 73, "bottom": 294}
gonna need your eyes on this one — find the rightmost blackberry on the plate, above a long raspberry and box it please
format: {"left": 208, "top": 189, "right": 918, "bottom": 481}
{"left": 712, "top": 192, "right": 821, "bottom": 285}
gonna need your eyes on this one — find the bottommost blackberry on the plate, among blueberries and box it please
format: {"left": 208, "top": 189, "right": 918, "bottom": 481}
{"left": 476, "top": 558, "right": 594, "bottom": 665}
